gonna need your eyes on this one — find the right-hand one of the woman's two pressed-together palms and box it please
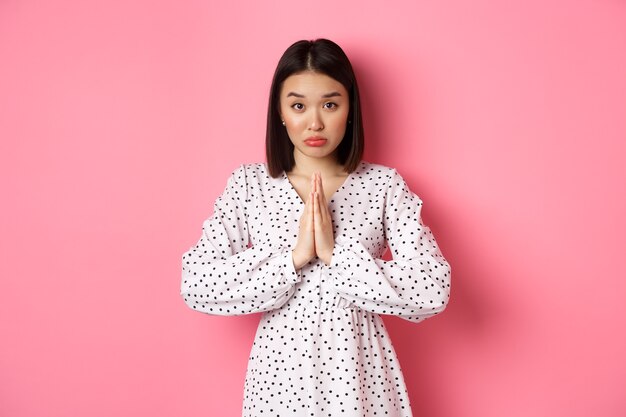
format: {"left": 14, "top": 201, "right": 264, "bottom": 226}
{"left": 313, "top": 173, "right": 335, "bottom": 265}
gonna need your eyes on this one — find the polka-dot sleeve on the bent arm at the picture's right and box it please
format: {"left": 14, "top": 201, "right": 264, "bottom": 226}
{"left": 327, "top": 170, "right": 451, "bottom": 322}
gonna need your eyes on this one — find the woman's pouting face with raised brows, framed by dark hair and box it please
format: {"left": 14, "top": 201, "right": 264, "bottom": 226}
{"left": 280, "top": 71, "right": 350, "bottom": 159}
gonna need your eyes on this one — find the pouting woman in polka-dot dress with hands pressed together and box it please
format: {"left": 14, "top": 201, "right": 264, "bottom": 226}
{"left": 181, "top": 39, "right": 450, "bottom": 417}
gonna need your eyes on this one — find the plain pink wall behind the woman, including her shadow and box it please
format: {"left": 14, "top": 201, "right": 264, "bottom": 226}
{"left": 0, "top": 0, "right": 626, "bottom": 417}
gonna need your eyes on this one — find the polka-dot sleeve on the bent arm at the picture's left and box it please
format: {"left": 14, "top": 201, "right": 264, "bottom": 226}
{"left": 180, "top": 165, "right": 301, "bottom": 315}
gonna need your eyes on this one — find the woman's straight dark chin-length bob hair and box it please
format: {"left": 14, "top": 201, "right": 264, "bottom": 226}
{"left": 265, "top": 39, "right": 365, "bottom": 178}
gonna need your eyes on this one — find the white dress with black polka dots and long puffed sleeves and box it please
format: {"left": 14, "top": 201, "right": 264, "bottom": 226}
{"left": 181, "top": 161, "right": 450, "bottom": 417}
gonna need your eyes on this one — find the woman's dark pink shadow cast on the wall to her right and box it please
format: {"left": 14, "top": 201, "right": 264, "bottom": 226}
{"left": 350, "top": 41, "right": 506, "bottom": 417}
